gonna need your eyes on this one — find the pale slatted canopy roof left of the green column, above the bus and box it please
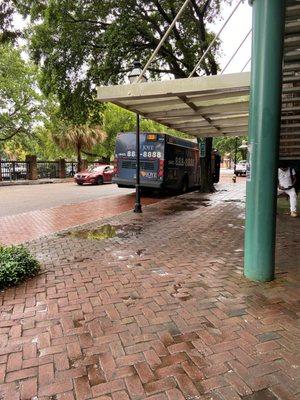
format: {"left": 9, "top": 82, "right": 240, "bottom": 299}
{"left": 97, "top": 72, "right": 250, "bottom": 137}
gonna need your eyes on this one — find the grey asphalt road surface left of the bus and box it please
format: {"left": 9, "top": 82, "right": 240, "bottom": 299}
{"left": 0, "top": 182, "right": 134, "bottom": 217}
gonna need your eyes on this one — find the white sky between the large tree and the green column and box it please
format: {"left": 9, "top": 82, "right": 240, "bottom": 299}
{"left": 211, "top": 0, "right": 252, "bottom": 74}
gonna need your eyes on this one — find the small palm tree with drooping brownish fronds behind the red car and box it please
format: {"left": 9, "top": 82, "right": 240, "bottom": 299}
{"left": 52, "top": 124, "right": 107, "bottom": 171}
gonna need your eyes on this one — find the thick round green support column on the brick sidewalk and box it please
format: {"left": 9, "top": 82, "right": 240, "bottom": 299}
{"left": 244, "top": 0, "right": 285, "bottom": 282}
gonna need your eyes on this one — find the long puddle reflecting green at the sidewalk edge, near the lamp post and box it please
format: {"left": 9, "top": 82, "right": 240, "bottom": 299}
{"left": 59, "top": 224, "right": 143, "bottom": 240}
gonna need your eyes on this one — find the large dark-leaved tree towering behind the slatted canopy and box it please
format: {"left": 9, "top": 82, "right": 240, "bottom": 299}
{"left": 18, "top": 0, "right": 230, "bottom": 120}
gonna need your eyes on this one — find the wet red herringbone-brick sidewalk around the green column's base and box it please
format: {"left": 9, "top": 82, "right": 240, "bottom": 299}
{"left": 0, "top": 183, "right": 300, "bottom": 400}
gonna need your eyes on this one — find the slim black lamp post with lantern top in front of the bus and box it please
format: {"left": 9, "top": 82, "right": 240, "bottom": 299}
{"left": 128, "top": 61, "right": 147, "bottom": 213}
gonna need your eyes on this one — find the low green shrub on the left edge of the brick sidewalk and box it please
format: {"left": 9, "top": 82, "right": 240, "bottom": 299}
{"left": 0, "top": 246, "right": 40, "bottom": 289}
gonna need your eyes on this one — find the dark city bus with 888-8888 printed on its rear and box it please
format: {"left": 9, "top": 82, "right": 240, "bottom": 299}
{"left": 113, "top": 132, "right": 200, "bottom": 192}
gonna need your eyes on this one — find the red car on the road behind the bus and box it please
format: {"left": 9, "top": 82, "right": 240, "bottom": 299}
{"left": 74, "top": 165, "right": 114, "bottom": 185}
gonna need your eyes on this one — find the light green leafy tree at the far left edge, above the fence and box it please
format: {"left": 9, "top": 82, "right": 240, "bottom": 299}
{"left": 0, "top": 44, "right": 43, "bottom": 143}
